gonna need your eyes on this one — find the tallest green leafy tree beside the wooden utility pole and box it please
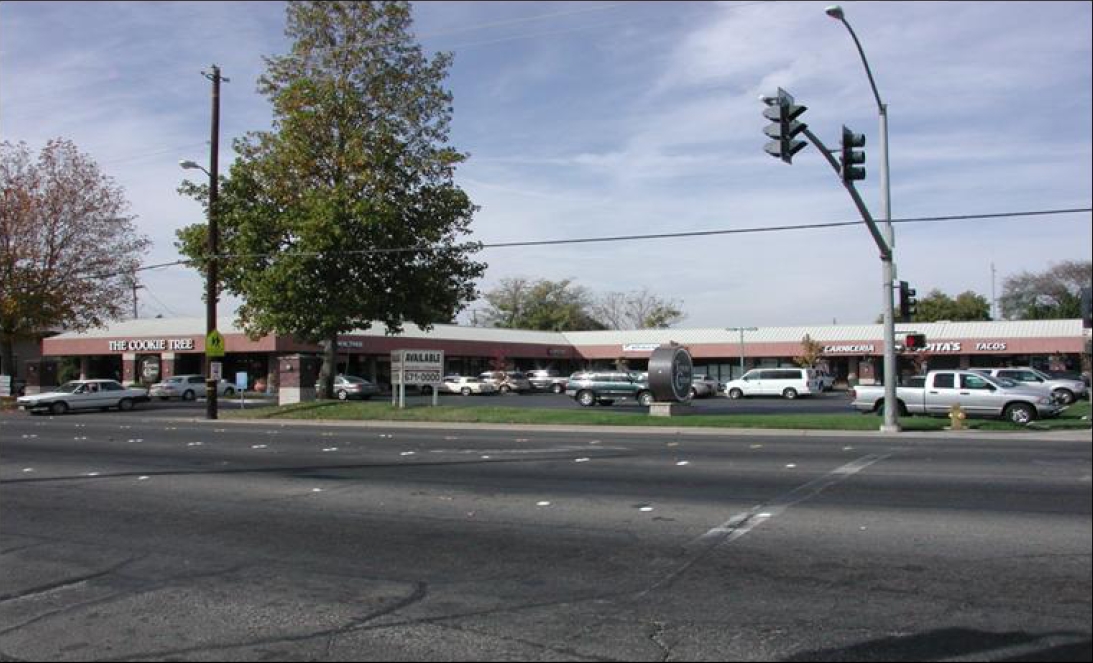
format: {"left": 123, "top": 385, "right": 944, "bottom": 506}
{"left": 178, "top": 1, "right": 485, "bottom": 395}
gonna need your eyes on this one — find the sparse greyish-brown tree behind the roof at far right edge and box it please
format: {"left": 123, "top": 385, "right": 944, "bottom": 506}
{"left": 1000, "top": 260, "right": 1093, "bottom": 320}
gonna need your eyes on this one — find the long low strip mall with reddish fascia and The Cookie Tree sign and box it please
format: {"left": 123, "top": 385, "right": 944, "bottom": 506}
{"left": 25, "top": 318, "right": 1086, "bottom": 392}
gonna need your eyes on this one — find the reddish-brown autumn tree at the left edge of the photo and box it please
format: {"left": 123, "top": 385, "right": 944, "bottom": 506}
{"left": 0, "top": 139, "right": 151, "bottom": 375}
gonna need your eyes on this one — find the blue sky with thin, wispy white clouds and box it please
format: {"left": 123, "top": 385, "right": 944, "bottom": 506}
{"left": 0, "top": 0, "right": 1093, "bottom": 328}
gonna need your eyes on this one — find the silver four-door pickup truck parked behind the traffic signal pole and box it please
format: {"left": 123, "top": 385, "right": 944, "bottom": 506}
{"left": 850, "top": 370, "right": 1063, "bottom": 425}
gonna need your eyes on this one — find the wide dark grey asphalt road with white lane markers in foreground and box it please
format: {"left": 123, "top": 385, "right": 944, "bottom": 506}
{"left": 0, "top": 411, "right": 1093, "bottom": 661}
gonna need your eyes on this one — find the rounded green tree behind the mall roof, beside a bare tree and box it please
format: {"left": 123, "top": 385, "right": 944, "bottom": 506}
{"left": 485, "top": 279, "right": 604, "bottom": 331}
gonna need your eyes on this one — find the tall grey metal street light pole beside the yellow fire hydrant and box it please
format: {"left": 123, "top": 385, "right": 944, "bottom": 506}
{"left": 824, "top": 4, "right": 900, "bottom": 433}
